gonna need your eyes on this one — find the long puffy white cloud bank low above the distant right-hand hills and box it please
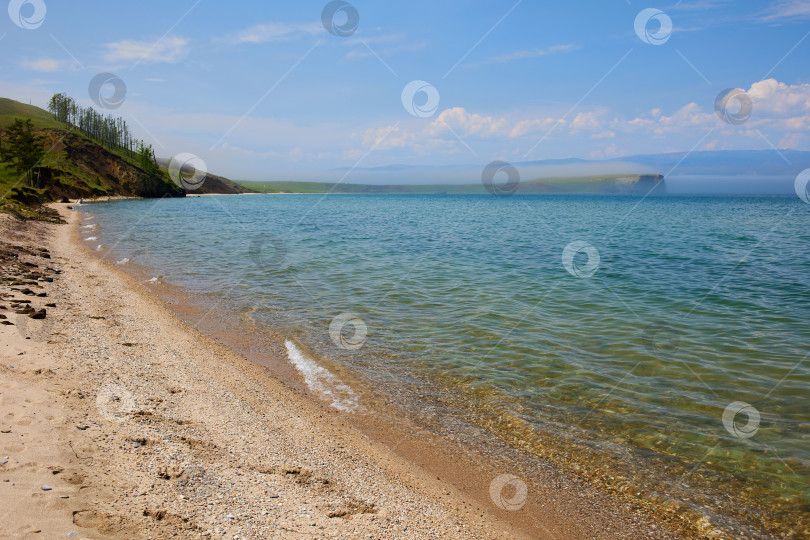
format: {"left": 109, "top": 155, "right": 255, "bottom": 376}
{"left": 363, "top": 79, "right": 810, "bottom": 157}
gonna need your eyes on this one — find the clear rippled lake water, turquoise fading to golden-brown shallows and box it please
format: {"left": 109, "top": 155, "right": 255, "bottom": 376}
{"left": 80, "top": 195, "right": 810, "bottom": 534}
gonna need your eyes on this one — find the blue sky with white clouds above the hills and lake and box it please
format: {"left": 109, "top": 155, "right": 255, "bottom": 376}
{"left": 0, "top": 0, "right": 810, "bottom": 179}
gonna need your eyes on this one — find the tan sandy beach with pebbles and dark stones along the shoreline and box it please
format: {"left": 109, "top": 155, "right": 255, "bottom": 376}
{"left": 0, "top": 205, "right": 672, "bottom": 539}
